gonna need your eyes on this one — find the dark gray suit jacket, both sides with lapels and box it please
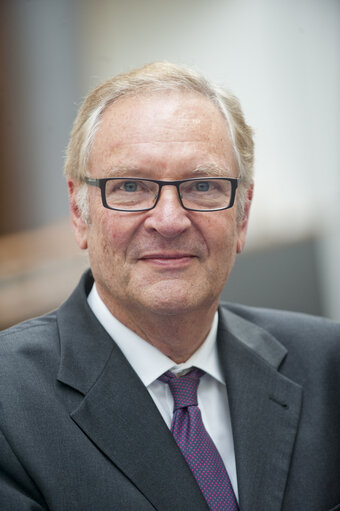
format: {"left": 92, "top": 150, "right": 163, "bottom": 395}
{"left": 0, "top": 275, "right": 340, "bottom": 511}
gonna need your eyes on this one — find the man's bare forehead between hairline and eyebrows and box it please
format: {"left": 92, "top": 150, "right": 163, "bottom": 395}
{"left": 90, "top": 91, "right": 234, "bottom": 175}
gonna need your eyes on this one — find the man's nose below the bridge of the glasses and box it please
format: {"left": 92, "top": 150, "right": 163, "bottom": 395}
{"left": 144, "top": 185, "right": 191, "bottom": 239}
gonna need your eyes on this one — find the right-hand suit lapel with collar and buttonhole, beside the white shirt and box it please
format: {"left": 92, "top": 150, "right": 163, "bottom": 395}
{"left": 219, "top": 310, "right": 302, "bottom": 511}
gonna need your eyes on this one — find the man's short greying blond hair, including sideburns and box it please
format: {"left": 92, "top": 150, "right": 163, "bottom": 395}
{"left": 65, "top": 62, "right": 254, "bottom": 218}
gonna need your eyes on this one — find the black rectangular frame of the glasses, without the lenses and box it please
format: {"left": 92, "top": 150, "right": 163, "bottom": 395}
{"left": 84, "top": 177, "right": 239, "bottom": 213}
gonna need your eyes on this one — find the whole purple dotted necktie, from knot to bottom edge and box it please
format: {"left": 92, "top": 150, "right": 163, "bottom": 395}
{"left": 159, "top": 369, "right": 239, "bottom": 511}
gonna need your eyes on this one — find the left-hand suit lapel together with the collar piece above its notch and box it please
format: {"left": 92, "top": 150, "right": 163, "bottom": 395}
{"left": 58, "top": 276, "right": 208, "bottom": 511}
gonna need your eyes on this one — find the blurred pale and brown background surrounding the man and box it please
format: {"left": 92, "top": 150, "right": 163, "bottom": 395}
{"left": 0, "top": 0, "right": 340, "bottom": 328}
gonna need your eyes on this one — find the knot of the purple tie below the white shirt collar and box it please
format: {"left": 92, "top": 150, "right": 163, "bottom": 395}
{"left": 158, "top": 369, "right": 204, "bottom": 411}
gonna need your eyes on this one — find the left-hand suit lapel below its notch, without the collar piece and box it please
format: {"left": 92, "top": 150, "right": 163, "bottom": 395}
{"left": 72, "top": 350, "right": 207, "bottom": 510}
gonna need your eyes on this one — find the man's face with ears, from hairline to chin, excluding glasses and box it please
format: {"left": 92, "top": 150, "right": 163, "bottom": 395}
{"left": 70, "top": 92, "right": 251, "bottom": 323}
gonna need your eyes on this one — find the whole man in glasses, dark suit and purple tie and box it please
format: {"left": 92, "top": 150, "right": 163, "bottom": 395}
{"left": 0, "top": 63, "right": 340, "bottom": 511}
